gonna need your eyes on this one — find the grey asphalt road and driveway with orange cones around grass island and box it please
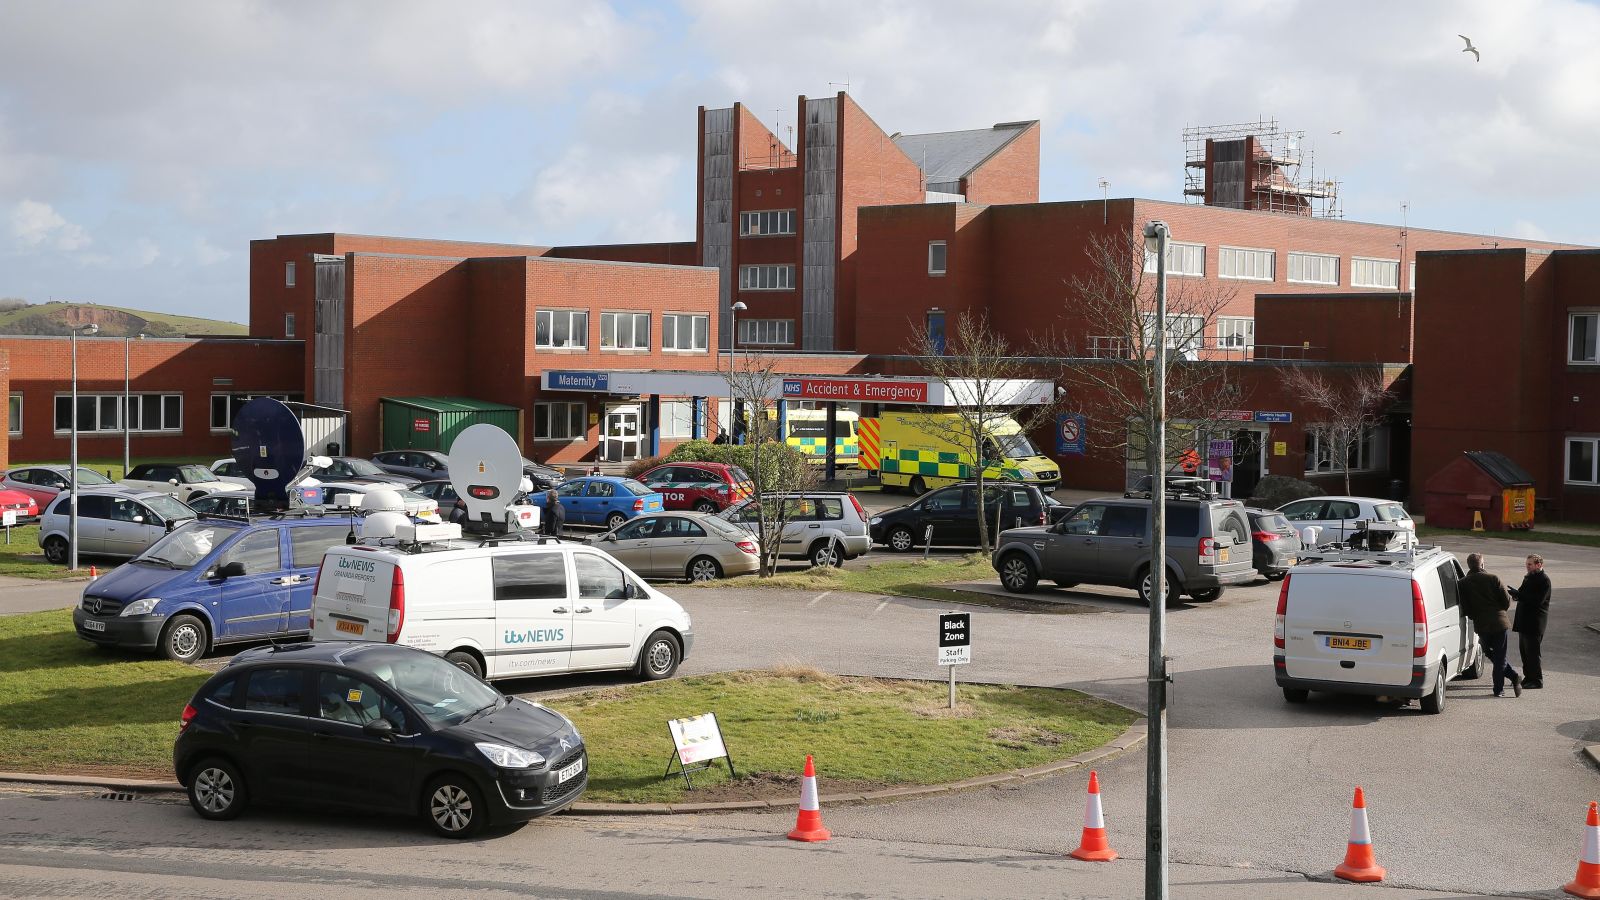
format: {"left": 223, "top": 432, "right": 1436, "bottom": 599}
{"left": 0, "top": 528, "right": 1600, "bottom": 897}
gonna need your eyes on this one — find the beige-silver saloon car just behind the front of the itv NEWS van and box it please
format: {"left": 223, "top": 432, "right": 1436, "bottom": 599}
{"left": 584, "top": 512, "right": 760, "bottom": 581}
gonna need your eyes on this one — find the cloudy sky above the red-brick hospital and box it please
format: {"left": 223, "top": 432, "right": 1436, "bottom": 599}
{"left": 0, "top": 0, "right": 1600, "bottom": 320}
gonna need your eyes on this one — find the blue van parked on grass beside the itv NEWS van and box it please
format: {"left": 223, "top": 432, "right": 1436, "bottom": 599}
{"left": 72, "top": 512, "right": 350, "bottom": 663}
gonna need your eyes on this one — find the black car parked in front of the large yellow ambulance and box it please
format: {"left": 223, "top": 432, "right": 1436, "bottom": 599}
{"left": 870, "top": 480, "right": 1048, "bottom": 552}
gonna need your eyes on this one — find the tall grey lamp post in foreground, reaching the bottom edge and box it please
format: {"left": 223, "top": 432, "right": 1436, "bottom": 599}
{"left": 1144, "top": 219, "right": 1171, "bottom": 900}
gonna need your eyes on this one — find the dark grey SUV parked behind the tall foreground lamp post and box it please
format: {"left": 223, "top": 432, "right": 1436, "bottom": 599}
{"left": 994, "top": 495, "right": 1256, "bottom": 604}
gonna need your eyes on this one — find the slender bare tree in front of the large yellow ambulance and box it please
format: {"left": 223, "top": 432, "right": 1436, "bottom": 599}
{"left": 907, "top": 312, "right": 1058, "bottom": 552}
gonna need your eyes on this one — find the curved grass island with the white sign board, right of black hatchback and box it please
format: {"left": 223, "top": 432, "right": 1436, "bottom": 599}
{"left": 563, "top": 668, "right": 1138, "bottom": 802}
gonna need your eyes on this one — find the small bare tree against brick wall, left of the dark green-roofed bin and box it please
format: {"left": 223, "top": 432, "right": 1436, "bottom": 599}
{"left": 1282, "top": 365, "right": 1394, "bottom": 493}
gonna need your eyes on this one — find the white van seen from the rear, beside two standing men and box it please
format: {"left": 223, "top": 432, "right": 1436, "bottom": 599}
{"left": 1272, "top": 528, "right": 1483, "bottom": 713}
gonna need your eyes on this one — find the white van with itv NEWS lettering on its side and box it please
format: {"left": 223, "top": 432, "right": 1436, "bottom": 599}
{"left": 310, "top": 525, "right": 694, "bottom": 681}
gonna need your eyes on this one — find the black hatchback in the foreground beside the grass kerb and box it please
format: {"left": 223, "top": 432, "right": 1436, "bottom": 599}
{"left": 173, "top": 642, "right": 589, "bottom": 838}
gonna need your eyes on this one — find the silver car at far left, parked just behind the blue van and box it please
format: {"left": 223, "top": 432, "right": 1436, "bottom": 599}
{"left": 38, "top": 485, "right": 195, "bottom": 565}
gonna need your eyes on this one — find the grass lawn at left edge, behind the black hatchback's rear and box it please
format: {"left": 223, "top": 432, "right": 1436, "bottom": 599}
{"left": 0, "top": 610, "right": 210, "bottom": 778}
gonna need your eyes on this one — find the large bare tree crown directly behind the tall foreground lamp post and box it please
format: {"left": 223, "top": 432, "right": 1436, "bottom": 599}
{"left": 1042, "top": 227, "right": 1246, "bottom": 486}
